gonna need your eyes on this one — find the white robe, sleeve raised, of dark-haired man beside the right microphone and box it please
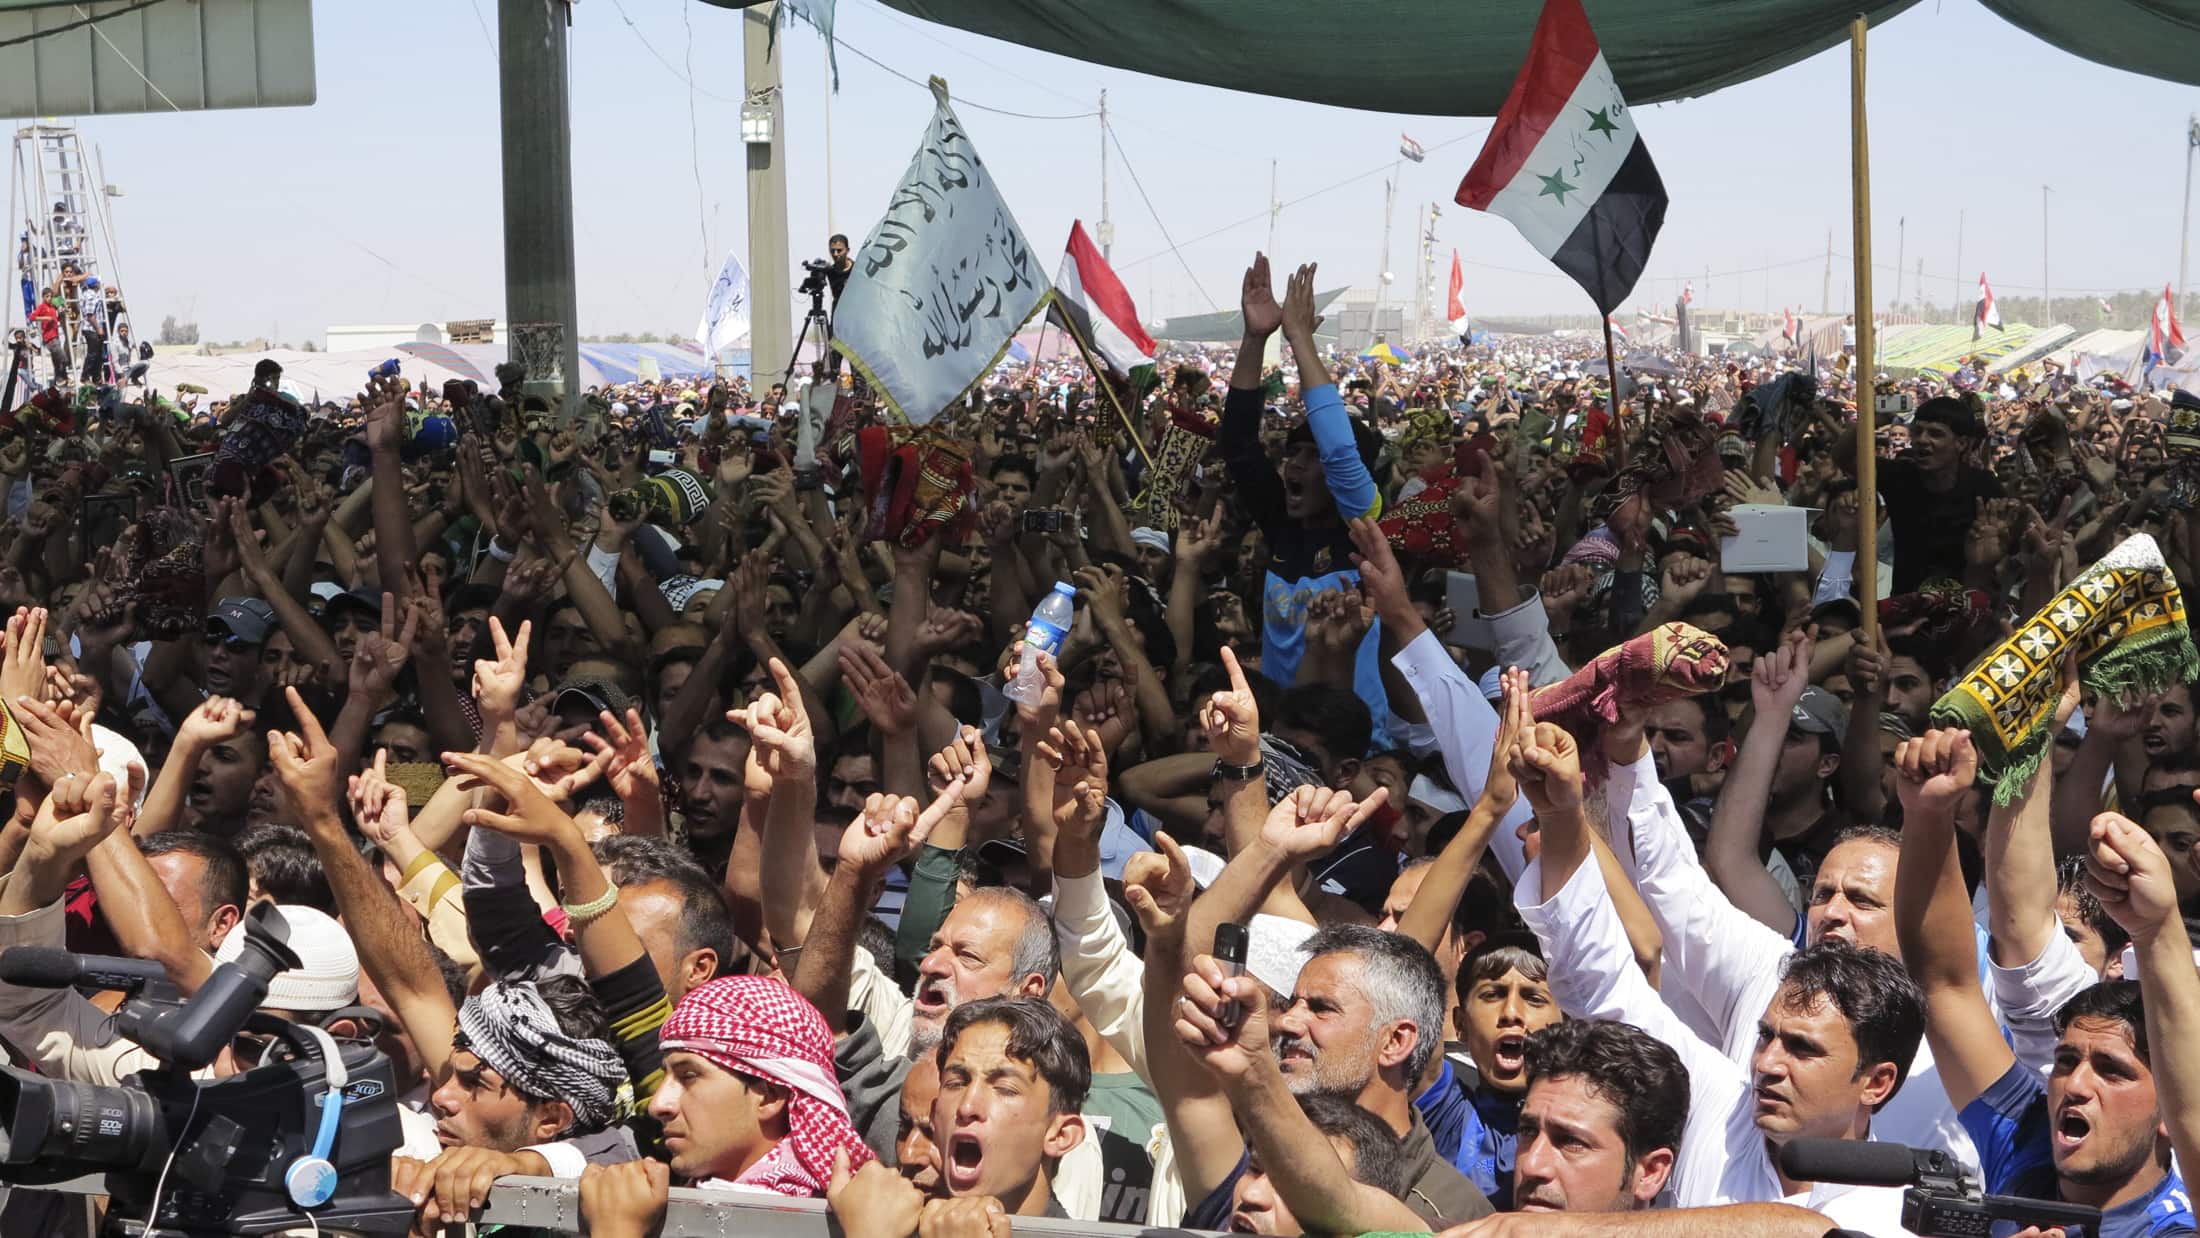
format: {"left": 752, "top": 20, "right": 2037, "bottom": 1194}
{"left": 1514, "top": 844, "right": 1905, "bottom": 1238}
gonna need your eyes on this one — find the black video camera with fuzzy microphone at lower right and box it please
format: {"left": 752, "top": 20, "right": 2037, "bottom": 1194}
{"left": 1780, "top": 1139, "right": 2101, "bottom": 1238}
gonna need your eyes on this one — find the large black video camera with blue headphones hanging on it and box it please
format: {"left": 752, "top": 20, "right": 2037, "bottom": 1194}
{"left": 0, "top": 904, "right": 414, "bottom": 1238}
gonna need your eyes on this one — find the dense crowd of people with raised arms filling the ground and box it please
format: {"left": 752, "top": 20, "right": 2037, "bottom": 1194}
{"left": 0, "top": 257, "right": 2200, "bottom": 1238}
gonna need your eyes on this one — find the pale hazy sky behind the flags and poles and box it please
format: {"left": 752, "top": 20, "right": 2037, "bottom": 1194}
{"left": 47, "top": 0, "right": 2200, "bottom": 341}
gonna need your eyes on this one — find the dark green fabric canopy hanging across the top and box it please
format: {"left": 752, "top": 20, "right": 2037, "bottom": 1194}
{"left": 711, "top": 0, "right": 2200, "bottom": 117}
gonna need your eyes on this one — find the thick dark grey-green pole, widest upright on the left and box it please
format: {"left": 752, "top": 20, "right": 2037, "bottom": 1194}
{"left": 497, "top": 0, "right": 581, "bottom": 422}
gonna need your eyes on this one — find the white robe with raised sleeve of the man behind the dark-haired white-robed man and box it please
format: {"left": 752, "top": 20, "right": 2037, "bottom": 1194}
{"left": 1604, "top": 754, "right": 1978, "bottom": 1165}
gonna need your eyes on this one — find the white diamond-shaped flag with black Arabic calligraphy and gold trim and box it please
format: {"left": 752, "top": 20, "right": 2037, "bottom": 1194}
{"left": 834, "top": 77, "right": 1052, "bottom": 424}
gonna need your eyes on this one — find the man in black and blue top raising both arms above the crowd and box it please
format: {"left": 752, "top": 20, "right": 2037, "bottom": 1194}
{"left": 1219, "top": 255, "right": 1386, "bottom": 743}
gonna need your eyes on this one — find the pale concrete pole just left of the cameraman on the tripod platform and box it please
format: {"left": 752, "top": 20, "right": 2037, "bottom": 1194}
{"left": 743, "top": 0, "right": 794, "bottom": 394}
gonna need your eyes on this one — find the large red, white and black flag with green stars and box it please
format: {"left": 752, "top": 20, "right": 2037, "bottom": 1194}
{"left": 1456, "top": 0, "right": 1665, "bottom": 314}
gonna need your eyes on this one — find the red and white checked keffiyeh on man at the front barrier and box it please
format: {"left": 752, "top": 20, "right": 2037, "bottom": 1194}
{"left": 658, "top": 976, "right": 873, "bottom": 1198}
